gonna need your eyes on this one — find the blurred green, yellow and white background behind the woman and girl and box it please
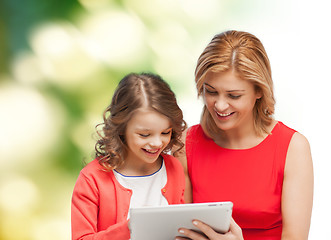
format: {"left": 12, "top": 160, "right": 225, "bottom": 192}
{"left": 0, "top": 0, "right": 331, "bottom": 240}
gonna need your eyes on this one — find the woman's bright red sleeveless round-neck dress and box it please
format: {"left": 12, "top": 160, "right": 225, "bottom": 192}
{"left": 186, "top": 122, "right": 295, "bottom": 240}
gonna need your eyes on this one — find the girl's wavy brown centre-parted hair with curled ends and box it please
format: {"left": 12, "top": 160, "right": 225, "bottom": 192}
{"left": 95, "top": 73, "right": 186, "bottom": 170}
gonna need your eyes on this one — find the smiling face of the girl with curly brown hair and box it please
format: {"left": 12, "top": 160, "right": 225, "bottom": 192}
{"left": 125, "top": 108, "right": 172, "bottom": 172}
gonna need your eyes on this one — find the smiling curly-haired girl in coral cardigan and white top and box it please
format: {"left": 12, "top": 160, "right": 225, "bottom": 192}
{"left": 71, "top": 73, "right": 186, "bottom": 240}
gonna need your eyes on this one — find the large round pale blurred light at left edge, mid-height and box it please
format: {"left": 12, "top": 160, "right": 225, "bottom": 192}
{"left": 0, "top": 83, "right": 64, "bottom": 168}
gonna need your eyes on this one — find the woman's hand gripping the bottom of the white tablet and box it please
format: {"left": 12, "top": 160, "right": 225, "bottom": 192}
{"left": 176, "top": 219, "right": 244, "bottom": 240}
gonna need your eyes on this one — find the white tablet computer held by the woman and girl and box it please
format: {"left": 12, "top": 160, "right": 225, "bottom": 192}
{"left": 129, "top": 202, "right": 233, "bottom": 240}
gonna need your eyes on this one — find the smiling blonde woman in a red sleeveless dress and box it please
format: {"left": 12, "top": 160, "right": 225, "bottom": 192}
{"left": 179, "top": 31, "right": 313, "bottom": 240}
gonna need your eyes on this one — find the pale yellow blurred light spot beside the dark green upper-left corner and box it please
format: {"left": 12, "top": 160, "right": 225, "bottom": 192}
{"left": 30, "top": 22, "right": 97, "bottom": 85}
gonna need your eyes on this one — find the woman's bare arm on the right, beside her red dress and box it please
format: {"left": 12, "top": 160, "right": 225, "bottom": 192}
{"left": 282, "top": 133, "right": 314, "bottom": 240}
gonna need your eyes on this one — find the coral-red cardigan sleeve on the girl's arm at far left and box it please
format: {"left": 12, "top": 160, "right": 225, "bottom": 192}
{"left": 71, "top": 173, "right": 130, "bottom": 240}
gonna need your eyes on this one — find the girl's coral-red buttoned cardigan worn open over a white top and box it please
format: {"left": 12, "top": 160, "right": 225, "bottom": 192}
{"left": 71, "top": 154, "right": 185, "bottom": 240}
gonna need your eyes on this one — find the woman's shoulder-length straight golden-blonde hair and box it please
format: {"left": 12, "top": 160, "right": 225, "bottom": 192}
{"left": 195, "top": 31, "right": 275, "bottom": 138}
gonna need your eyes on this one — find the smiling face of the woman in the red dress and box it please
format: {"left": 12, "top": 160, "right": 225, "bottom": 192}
{"left": 203, "top": 71, "right": 261, "bottom": 131}
